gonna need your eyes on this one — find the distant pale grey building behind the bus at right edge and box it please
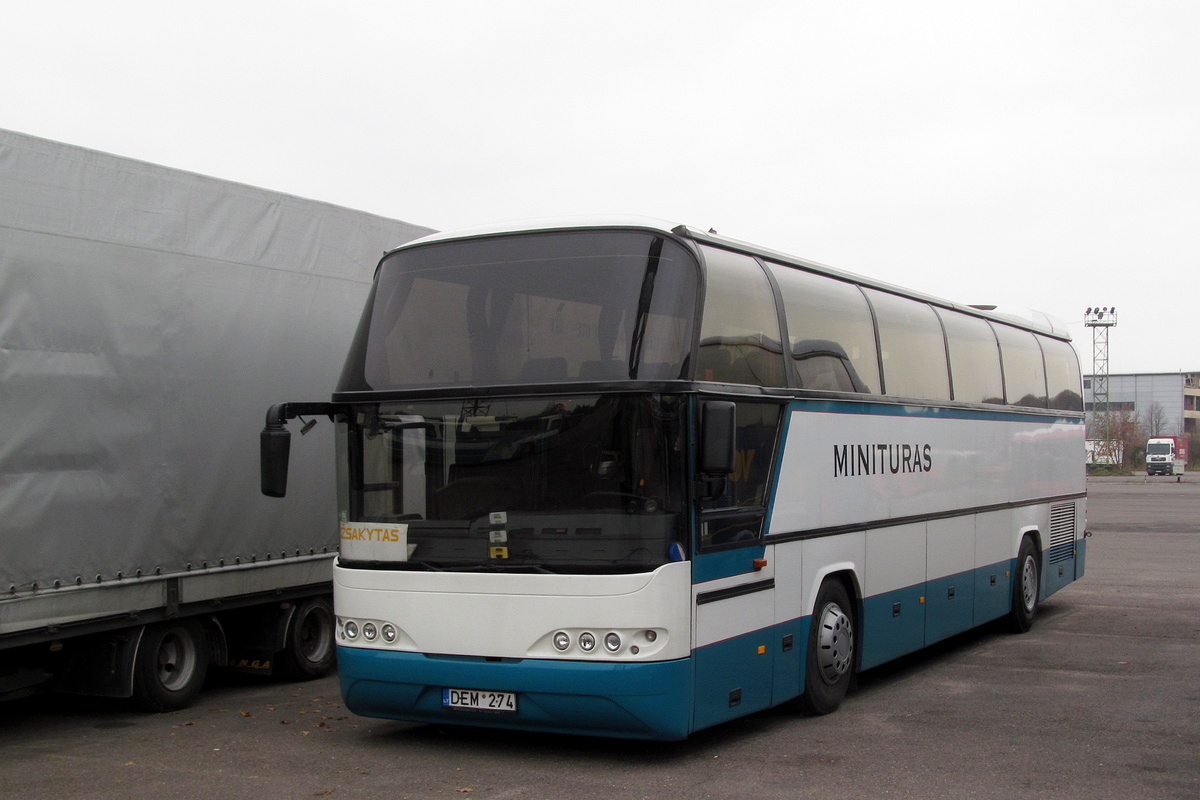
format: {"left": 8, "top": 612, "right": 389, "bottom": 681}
{"left": 1084, "top": 372, "right": 1200, "bottom": 437}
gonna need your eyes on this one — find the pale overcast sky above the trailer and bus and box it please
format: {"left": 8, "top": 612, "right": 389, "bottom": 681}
{"left": 0, "top": 0, "right": 1200, "bottom": 373}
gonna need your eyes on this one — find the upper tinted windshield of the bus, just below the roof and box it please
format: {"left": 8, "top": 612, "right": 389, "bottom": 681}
{"left": 338, "top": 230, "right": 698, "bottom": 392}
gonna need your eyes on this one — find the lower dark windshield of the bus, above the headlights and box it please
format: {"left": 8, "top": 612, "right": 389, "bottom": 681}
{"left": 338, "top": 393, "right": 685, "bottom": 572}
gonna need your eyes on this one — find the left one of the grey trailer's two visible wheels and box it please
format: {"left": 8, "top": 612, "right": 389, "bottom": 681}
{"left": 133, "top": 619, "right": 211, "bottom": 711}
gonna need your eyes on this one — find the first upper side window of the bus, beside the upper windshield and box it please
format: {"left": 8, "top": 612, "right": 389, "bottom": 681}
{"left": 696, "top": 247, "right": 787, "bottom": 386}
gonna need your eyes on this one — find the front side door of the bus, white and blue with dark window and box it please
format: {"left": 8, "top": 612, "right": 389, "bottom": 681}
{"left": 692, "top": 403, "right": 780, "bottom": 729}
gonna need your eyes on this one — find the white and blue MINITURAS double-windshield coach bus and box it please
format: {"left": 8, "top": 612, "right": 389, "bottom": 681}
{"left": 262, "top": 218, "right": 1086, "bottom": 740}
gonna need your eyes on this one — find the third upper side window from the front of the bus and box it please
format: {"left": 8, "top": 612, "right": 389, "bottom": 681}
{"left": 865, "top": 289, "right": 950, "bottom": 399}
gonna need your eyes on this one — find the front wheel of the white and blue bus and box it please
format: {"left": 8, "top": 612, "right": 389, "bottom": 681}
{"left": 800, "top": 579, "right": 856, "bottom": 715}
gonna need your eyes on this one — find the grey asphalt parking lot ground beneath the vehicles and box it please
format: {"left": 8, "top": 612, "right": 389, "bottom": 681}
{"left": 0, "top": 476, "right": 1200, "bottom": 800}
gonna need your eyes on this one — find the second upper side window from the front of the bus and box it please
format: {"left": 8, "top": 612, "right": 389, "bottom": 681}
{"left": 768, "top": 264, "right": 880, "bottom": 393}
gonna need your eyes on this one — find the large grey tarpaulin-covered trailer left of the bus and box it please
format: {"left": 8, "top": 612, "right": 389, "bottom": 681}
{"left": 0, "top": 130, "right": 430, "bottom": 709}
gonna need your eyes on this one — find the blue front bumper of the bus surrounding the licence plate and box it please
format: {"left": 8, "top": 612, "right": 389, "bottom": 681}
{"left": 337, "top": 646, "right": 692, "bottom": 740}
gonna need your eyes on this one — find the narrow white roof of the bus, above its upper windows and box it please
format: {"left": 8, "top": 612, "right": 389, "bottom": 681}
{"left": 388, "top": 215, "right": 1070, "bottom": 341}
